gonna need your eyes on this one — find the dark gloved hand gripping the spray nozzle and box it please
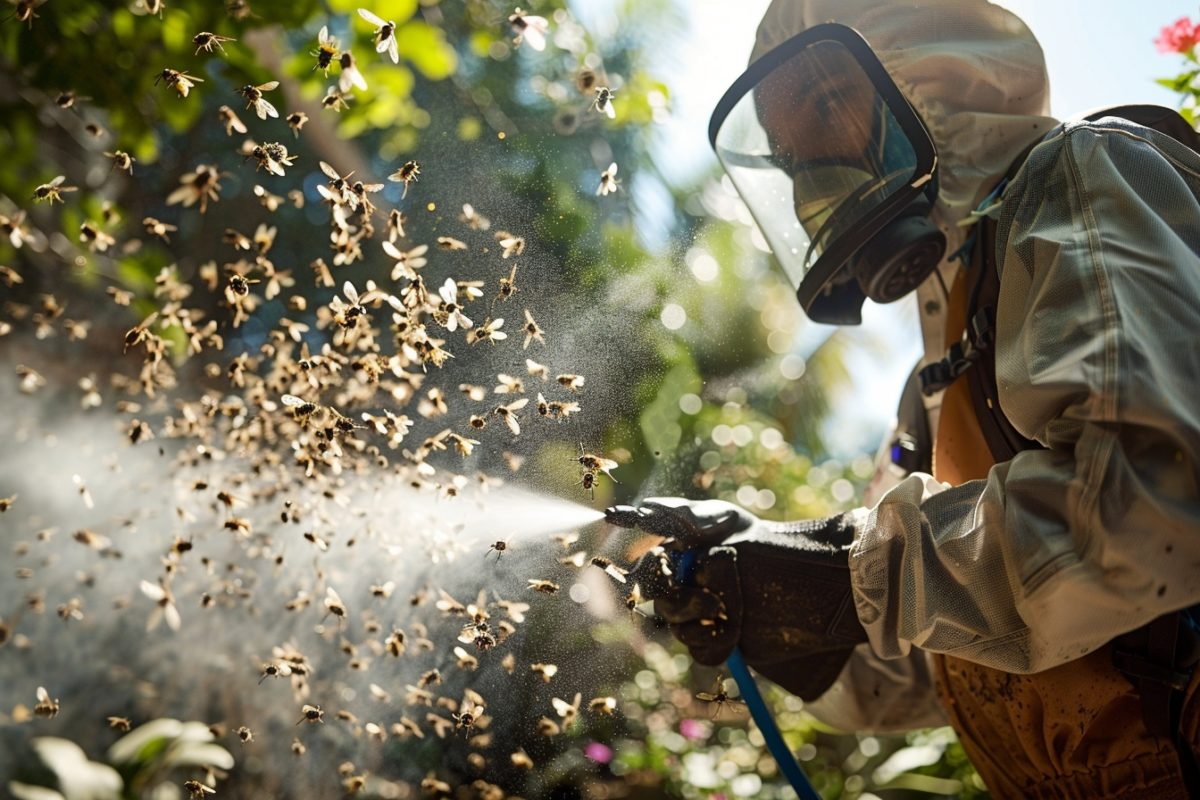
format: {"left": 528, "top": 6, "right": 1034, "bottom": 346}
{"left": 605, "top": 498, "right": 866, "bottom": 700}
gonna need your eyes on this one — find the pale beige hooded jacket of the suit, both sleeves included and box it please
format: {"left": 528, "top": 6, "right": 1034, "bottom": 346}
{"left": 752, "top": 0, "right": 1200, "bottom": 730}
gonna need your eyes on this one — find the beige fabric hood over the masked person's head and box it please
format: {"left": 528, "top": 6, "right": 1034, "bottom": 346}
{"left": 750, "top": 0, "right": 1057, "bottom": 297}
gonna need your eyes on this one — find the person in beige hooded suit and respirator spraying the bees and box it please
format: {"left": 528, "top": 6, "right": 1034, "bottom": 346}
{"left": 608, "top": 0, "right": 1200, "bottom": 798}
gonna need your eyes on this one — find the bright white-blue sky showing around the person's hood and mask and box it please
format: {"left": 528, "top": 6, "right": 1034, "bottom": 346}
{"left": 638, "top": 0, "right": 1200, "bottom": 456}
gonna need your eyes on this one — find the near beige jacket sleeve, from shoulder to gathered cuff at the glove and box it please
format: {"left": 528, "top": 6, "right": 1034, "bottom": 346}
{"left": 851, "top": 118, "right": 1200, "bottom": 673}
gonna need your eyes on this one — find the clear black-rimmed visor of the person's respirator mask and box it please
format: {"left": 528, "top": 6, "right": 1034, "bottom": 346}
{"left": 709, "top": 23, "right": 936, "bottom": 321}
